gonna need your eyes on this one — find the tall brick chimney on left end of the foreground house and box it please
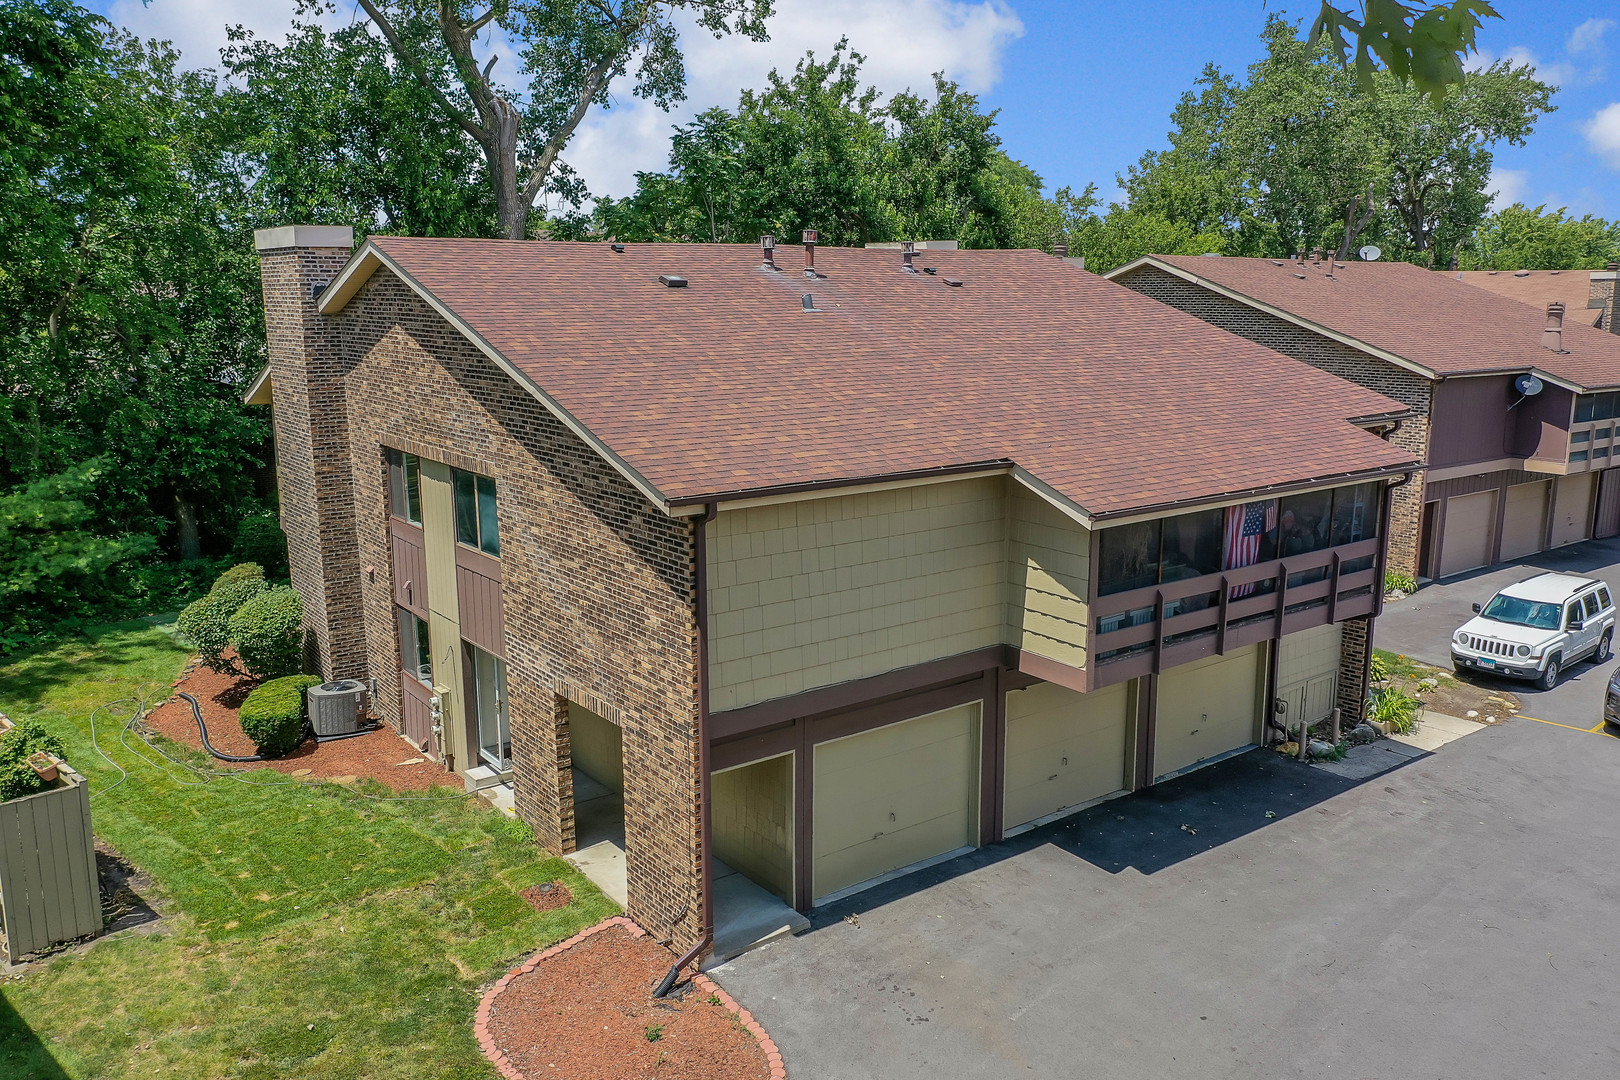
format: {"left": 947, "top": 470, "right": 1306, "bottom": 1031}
{"left": 253, "top": 225, "right": 366, "bottom": 678}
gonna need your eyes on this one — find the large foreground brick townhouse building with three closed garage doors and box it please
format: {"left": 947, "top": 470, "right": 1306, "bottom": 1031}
{"left": 248, "top": 227, "right": 1421, "bottom": 949}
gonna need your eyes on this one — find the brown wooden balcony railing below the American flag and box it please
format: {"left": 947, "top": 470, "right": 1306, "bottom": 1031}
{"left": 1089, "top": 538, "right": 1383, "bottom": 688}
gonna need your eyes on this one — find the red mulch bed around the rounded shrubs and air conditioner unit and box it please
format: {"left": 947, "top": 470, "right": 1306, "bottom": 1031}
{"left": 146, "top": 664, "right": 455, "bottom": 792}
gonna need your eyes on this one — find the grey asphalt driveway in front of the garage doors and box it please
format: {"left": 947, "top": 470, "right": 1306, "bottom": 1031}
{"left": 714, "top": 544, "right": 1620, "bottom": 1080}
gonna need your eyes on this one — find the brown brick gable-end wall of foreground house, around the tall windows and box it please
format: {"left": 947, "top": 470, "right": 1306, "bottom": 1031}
{"left": 340, "top": 274, "right": 698, "bottom": 944}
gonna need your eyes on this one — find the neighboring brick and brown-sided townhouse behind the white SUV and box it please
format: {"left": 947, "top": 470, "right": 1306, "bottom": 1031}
{"left": 1108, "top": 256, "right": 1620, "bottom": 580}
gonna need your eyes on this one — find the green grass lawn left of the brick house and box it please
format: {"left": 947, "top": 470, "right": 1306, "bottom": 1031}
{"left": 0, "top": 622, "right": 617, "bottom": 1080}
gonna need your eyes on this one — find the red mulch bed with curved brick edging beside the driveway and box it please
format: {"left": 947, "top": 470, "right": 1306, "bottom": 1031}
{"left": 489, "top": 926, "right": 771, "bottom": 1080}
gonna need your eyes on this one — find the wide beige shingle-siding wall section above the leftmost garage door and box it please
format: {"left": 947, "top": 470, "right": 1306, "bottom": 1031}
{"left": 708, "top": 476, "right": 1006, "bottom": 712}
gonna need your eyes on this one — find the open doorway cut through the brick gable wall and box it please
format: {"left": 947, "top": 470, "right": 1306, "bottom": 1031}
{"left": 569, "top": 701, "right": 629, "bottom": 907}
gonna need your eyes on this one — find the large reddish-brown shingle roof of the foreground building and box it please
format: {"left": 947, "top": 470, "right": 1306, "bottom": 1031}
{"left": 360, "top": 238, "right": 1413, "bottom": 515}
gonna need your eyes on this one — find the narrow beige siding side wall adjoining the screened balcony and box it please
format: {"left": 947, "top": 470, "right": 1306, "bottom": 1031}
{"left": 1008, "top": 486, "right": 1092, "bottom": 667}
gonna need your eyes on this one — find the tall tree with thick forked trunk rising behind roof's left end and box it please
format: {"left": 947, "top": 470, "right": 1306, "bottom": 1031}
{"left": 360, "top": 0, "right": 773, "bottom": 240}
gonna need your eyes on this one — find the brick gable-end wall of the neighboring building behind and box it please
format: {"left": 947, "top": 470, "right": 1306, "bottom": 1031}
{"left": 1118, "top": 267, "right": 1434, "bottom": 576}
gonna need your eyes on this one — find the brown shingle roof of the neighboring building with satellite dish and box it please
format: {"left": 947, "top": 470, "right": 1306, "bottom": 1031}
{"left": 1152, "top": 256, "right": 1620, "bottom": 389}
